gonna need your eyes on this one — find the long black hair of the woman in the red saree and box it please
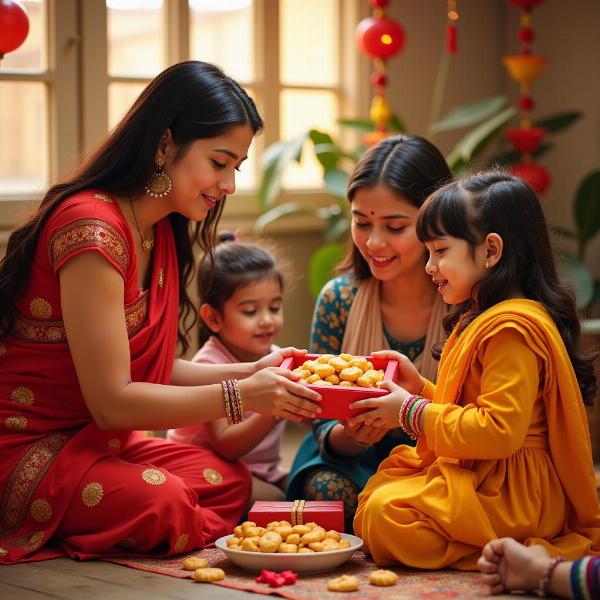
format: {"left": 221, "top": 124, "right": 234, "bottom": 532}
{"left": 0, "top": 61, "right": 263, "bottom": 352}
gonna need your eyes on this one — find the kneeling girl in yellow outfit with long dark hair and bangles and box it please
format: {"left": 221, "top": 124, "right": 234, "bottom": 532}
{"left": 350, "top": 172, "right": 600, "bottom": 570}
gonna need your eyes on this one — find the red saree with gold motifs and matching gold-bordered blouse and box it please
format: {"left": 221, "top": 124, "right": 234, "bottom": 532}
{"left": 0, "top": 190, "right": 250, "bottom": 564}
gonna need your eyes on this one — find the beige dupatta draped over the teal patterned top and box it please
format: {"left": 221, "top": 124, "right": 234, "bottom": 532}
{"left": 341, "top": 277, "right": 449, "bottom": 382}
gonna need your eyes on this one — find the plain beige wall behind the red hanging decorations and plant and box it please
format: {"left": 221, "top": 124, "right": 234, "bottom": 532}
{"left": 267, "top": 0, "right": 600, "bottom": 352}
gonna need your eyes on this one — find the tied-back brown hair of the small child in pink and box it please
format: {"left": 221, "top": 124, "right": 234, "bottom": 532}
{"left": 197, "top": 232, "right": 288, "bottom": 346}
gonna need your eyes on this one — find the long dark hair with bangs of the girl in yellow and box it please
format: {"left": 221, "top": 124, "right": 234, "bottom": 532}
{"left": 417, "top": 170, "right": 597, "bottom": 404}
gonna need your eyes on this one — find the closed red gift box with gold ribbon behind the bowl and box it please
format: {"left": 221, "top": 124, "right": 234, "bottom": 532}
{"left": 248, "top": 500, "right": 344, "bottom": 532}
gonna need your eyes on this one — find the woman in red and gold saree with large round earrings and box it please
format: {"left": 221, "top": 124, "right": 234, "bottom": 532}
{"left": 0, "top": 61, "right": 319, "bottom": 564}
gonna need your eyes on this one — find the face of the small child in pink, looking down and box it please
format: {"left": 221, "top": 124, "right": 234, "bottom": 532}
{"left": 215, "top": 278, "right": 283, "bottom": 361}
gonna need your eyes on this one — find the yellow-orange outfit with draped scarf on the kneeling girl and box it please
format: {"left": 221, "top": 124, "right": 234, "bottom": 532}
{"left": 354, "top": 300, "right": 600, "bottom": 569}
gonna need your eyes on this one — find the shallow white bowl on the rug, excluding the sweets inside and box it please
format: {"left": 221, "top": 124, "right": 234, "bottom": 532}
{"left": 215, "top": 533, "right": 362, "bottom": 573}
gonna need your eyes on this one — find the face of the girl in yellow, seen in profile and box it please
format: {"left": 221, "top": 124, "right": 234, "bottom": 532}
{"left": 425, "top": 236, "right": 486, "bottom": 304}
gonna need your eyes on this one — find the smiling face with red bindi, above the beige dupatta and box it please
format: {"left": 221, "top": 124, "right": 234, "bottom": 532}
{"left": 352, "top": 184, "right": 424, "bottom": 281}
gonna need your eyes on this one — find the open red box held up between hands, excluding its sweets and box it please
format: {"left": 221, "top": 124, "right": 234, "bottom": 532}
{"left": 281, "top": 354, "right": 398, "bottom": 420}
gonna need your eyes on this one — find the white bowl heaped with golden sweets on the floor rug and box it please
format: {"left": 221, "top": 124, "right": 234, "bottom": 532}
{"left": 215, "top": 521, "right": 363, "bottom": 573}
